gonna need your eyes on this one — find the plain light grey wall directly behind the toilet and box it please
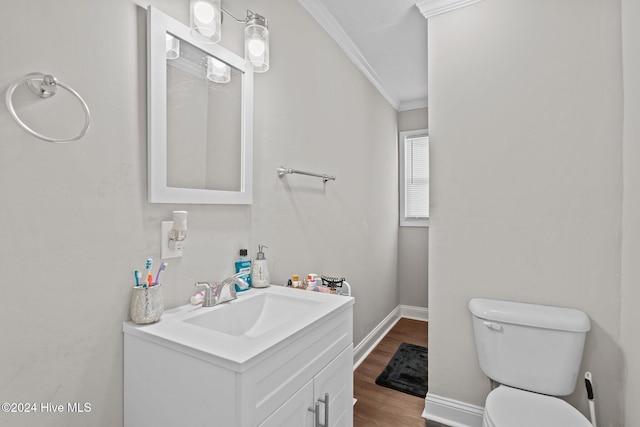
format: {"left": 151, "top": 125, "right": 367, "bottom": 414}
{"left": 429, "top": 0, "right": 624, "bottom": 426}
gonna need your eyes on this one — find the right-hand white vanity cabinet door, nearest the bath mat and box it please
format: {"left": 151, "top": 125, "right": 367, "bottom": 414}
{"left": 312, "top": 344, "right": 353, "bottom": 427}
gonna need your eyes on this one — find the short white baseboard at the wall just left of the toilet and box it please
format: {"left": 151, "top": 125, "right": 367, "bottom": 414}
{"left": 422, "top": 393, "right": 484, "bottom": 427}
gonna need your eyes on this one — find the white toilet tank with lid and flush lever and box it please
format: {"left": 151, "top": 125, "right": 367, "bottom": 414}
{"left": 469, "top": 298, "right": 591, "bottom": 396}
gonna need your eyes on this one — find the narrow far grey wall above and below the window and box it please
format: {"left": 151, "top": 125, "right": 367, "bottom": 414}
{"left": 398, "top": 108, "right": 429, "bottom": 308}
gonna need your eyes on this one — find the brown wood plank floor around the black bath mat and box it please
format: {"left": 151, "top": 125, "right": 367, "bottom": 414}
{"left": 353, "top": 318, "right": 438, "bottom": 427}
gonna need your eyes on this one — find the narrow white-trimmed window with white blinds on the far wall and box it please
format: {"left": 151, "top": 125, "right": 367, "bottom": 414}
{"left": 399, "top": 129, "right": 429, "bottom": 227}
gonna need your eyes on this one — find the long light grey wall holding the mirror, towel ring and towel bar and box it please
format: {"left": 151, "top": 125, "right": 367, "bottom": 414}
{"left": 0, "top": 0, "right": 398, "bottom": 427}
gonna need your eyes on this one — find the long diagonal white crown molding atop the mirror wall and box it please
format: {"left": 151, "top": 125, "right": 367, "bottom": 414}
{"left": 298, "top": 0, "right": 400, "bottom": 110}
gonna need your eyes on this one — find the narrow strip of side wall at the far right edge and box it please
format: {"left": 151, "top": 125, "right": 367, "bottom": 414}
{"left": 621, "top": 0, "right": 640, "bottom": 426}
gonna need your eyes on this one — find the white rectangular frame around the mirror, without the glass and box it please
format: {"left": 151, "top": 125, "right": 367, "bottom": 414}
{"left": 147, "top": 6, "right": 253, "bottom": 205}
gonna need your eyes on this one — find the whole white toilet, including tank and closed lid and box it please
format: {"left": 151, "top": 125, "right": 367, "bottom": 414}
{"left": 469, "top": 298, "right": 591, "bottom": 427}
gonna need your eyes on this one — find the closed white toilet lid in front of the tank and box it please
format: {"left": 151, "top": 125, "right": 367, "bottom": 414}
{"left": 484, "top": 385, "right": 592, "bottom": 427}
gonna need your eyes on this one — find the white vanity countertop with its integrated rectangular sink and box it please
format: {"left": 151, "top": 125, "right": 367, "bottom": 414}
{"left": 123, "top": 285, "right": 353, "bottom": 372}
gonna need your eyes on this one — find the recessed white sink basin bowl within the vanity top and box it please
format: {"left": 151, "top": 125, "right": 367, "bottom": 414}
{"left": 184, "top": 291, "right": 322, "bottom": 337}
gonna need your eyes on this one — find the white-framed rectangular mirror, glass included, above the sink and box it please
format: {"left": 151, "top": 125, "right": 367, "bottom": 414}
{"left": 147, "top": 6, "right": 253, "bottom": 204}
